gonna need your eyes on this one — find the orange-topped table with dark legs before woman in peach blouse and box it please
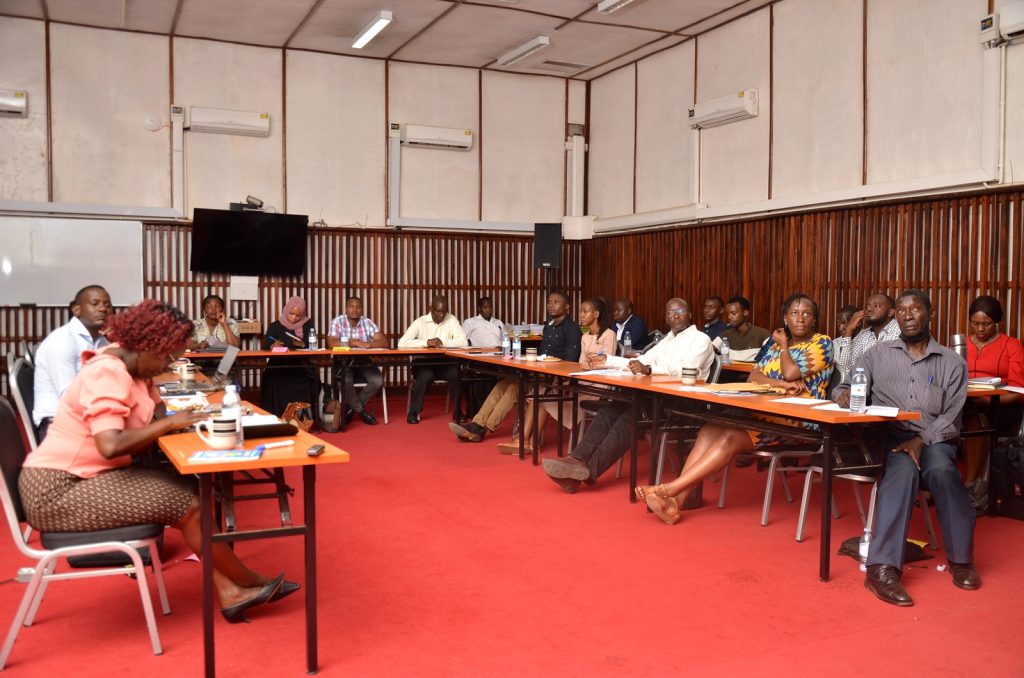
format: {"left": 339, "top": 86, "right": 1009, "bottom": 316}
{"left": 159, "top": 405, "right": 349, "bottom": 676}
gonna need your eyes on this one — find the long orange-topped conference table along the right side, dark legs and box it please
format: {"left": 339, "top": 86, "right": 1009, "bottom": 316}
{"left": 450, "top": 350, "right": 921, "bottom": 582}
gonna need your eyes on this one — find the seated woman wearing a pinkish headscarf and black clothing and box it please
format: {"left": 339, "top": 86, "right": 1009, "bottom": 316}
{"left": 260, "top": 297, "right": 318, "bottom": 416}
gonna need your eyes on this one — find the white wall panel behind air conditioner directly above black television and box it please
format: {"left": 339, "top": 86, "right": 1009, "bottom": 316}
{"left": 174, "top": 38, "right": 286, "bottom": 217}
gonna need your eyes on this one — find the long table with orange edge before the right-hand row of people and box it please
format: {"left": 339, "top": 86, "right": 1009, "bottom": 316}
{"left": 450, "top": 351, "right": 921, "bottom": 582}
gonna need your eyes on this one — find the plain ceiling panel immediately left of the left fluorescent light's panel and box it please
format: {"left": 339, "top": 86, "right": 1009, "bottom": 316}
{"left": 177, "top": 0, "right": 315, "bottom": 47}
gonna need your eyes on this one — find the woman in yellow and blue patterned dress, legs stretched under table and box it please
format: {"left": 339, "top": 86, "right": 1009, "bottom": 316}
{"left": 636, "top": 293, "right": 833, "bottom": 525}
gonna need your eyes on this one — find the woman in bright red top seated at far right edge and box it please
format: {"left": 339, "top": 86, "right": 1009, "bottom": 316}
{"left": 964, "top": 296, "right": 1024, "bottom": 496}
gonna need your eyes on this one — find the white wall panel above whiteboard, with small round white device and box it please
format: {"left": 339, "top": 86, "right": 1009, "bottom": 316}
{"left": 50, "top": 24, "right": 171, "bottom": 207}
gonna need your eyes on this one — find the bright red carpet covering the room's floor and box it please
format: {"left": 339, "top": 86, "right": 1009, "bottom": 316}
{"left": 0, "top": 400, "right": 1024, "bottom": 676}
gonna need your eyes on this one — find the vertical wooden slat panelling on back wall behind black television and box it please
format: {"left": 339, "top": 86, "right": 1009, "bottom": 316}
{"left": 0, "top": 224, "right": 583, "bottom": 393}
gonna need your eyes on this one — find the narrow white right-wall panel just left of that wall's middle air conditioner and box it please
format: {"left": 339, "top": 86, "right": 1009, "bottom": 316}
{"left": 636, "top": 40, "right": 696, "bottom": 212}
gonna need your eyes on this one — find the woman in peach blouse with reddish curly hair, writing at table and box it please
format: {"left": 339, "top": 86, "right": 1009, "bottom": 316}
{"left": 18, "top": 300, "right": 299, "bottom": 623}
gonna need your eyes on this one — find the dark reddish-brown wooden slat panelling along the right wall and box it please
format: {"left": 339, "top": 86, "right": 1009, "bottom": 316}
{"left": 583, "top": 188, "right": 1024, "bottom": 343}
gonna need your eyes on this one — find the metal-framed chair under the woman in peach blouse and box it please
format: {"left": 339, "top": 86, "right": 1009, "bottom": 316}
{"left": 0, "top": 397, "right": 171, "bottom": 670}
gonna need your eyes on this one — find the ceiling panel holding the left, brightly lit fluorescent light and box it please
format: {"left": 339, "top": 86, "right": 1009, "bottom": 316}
{"left": 289, "top": 0, "right": 453, "bottom": 58}
